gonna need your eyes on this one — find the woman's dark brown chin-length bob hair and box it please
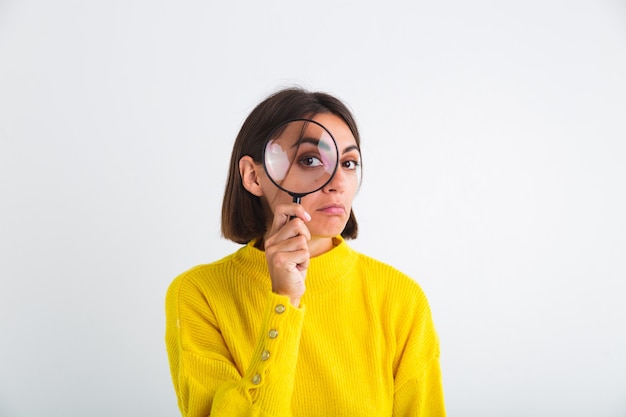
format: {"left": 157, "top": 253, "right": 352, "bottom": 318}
{"left": 222, "top": 87, "right": 361, "bottom": 244}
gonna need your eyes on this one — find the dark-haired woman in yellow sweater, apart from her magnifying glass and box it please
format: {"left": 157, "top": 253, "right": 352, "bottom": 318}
{"left": 166, "top": 88, "right": 445, "bottom": 417}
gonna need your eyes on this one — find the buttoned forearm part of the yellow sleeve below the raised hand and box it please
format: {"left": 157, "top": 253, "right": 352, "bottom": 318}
{"left": 242, "top": 293, "right": 305, "bottom": 415}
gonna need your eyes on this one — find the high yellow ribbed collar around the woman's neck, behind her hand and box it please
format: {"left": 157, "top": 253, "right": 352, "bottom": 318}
{"left": 233, "top": 237, "right": 359, "bottom": 292}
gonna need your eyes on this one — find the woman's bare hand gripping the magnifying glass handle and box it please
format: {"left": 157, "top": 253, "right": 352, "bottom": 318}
{"left": 265, "top": 203, "right": 311, "bottom": 307}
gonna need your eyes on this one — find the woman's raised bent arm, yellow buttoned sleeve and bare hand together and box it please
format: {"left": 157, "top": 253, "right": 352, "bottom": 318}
{"left": 166, "top": 203, "right": 310, "bottom": 417}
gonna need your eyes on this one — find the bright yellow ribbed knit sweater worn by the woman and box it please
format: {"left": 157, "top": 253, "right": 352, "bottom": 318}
{"left": 165, "top": 238, "right": 445, "bottom": 417}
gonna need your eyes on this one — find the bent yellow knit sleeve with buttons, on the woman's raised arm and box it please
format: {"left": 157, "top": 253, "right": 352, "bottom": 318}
{"left": 166, "top": 272, "right": 304, "bottom": 417}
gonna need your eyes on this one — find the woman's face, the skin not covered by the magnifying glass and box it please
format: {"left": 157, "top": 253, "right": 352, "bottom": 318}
{"left": 260, "top": 113, "right": 361, "bottom": 238}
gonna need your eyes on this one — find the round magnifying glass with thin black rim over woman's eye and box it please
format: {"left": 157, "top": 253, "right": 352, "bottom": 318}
{"left": 263, "top": 119, "right": 339, "bottom": 204}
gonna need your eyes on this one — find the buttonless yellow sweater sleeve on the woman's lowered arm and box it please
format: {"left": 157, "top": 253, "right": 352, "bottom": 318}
{"left": 393, "top": 288, "right": 446, "bottom": 417}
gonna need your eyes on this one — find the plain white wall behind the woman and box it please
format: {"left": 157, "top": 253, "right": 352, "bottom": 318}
{"left": 0, "top": 0, "right": 626, "bottom": 417}
